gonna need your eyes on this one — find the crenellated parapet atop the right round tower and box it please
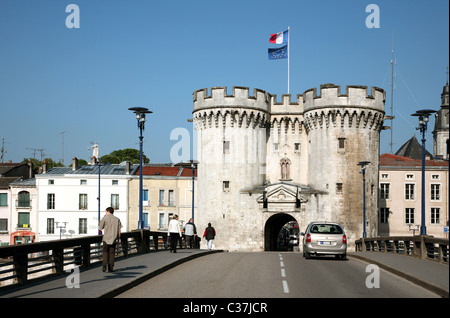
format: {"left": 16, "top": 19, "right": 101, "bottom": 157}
{"left": 303, "top": 84, "right": 386, "bottom": 112}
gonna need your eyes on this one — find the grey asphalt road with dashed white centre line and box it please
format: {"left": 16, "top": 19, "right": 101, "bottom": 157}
{"left": 118, "top": 252, "right": 438, "bottom": 298}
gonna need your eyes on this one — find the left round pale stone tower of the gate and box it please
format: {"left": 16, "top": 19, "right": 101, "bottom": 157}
{"left": 193, "top": 87, "right": 270, "bottom": 250}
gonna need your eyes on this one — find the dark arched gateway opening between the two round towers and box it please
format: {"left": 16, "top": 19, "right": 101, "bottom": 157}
{"left": 264, "top": 213, "right": 298, "bottom": 251}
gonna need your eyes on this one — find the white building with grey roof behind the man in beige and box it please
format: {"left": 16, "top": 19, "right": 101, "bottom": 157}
{"left": 36, "top": 158, "right": 138, "bottom": 241}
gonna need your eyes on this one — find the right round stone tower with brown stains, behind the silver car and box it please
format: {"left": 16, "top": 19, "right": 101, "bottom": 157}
{"left": 303, "top": 84, "right": 385, "bottom": 243}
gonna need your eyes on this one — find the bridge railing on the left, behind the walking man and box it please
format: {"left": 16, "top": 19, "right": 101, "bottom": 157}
{"left": 0, "top": 230, "right": 185, "bottom": 288}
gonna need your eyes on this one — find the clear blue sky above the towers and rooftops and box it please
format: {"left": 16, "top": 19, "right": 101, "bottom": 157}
{"left": 0, "top": 0, "right": 449, "bottom": 165}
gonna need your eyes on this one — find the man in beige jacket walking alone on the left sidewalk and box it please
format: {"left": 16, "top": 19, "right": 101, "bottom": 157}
{"left": 100, "top": 207, "right": 122, "bottom": 272}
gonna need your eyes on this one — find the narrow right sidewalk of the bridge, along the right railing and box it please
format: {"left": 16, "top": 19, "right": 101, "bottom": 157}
{"left": 347, "top": 252, "right": 449, "bottom": 298}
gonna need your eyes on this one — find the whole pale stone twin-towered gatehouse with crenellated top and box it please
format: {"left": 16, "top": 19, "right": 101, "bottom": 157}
{"left": 193, "top": 84, "right": 385, "bottom": 251}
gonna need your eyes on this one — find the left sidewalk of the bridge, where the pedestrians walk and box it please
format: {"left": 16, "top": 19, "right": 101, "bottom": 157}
{"left": 0, "top": 249, "right": 222, "bottom": 298}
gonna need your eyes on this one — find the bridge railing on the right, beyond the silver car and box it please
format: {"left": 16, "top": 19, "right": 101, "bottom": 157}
{"left": 355, "top": 235, "right": 449, "bottom": 265}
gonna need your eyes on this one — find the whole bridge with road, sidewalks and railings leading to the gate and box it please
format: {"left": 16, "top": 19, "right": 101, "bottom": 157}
{"left": 0, "top": 230, "right": 449, "bottom": 298}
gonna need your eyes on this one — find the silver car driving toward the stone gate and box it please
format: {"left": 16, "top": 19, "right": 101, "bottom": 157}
{"left": 301, "top": 222, "right": 347, "bottom": 259}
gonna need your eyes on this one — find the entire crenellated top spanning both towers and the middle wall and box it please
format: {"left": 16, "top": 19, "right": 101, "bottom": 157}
{"left": 193, "top": 84, "right": 386, "bottom": 130}
